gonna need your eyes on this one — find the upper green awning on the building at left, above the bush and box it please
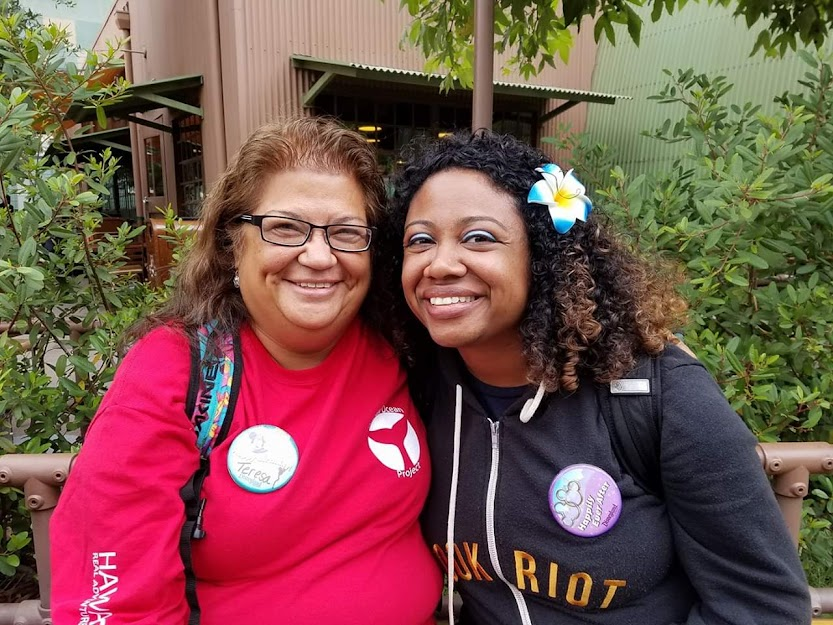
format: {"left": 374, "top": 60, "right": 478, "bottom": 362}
{"left": 67, "top": 75, "right": 203, "bottom": 131}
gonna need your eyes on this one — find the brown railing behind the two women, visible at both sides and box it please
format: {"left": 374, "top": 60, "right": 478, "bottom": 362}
{"left": 0, "top": 443, "right": 833, "bottom": 625}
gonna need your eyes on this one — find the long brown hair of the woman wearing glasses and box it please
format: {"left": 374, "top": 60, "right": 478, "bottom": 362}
{"left": 127, "top": 117, "right": 387, "bottom": 340}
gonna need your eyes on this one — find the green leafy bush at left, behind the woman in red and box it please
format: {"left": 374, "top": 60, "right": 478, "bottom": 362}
{"left": 0, "top": 0, "right": 167, "bottom": 579}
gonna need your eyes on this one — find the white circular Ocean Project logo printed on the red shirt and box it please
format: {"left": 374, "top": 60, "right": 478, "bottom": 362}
{"left": 367, "top": 406, "right": 420, "bottom": 477}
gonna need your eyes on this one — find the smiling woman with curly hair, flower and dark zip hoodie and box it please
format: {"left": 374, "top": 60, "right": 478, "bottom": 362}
{"left": 389, "top": 133, "right": 810, "bottom": 625}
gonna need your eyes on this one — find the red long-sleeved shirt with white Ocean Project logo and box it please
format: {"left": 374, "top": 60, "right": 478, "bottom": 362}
{"left": 51, "top": 321, "right": 441, "bottom": 625}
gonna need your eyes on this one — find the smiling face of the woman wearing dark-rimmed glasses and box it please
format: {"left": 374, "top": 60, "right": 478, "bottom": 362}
{"left": 237, "top": 169, "right": 370, "bottom": 355}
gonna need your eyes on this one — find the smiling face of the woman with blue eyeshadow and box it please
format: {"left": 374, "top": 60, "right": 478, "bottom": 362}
{"left": 402, "top": 169, "right": 530, "bottom": 350}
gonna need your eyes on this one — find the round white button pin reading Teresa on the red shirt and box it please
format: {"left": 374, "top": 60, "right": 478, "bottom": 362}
{"left": 228, "top": 425, "right": 299, "bottom": 493}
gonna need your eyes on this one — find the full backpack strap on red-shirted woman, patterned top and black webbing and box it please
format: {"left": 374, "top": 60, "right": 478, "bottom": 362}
{"left": 179, "top": 321, "right": 243, "bottom": 625}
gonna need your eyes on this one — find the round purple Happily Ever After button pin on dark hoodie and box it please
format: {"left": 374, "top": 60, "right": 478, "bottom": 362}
{"left": 549, "top": 464, "right": 622, "bottom": 538}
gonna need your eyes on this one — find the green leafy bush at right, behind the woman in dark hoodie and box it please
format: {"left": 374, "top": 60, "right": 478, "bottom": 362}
{"left": 553, "top": 53, "right": 833, "bottom": 586}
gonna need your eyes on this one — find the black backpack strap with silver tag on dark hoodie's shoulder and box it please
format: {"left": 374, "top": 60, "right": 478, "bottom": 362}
{"left": 598, "top": 356, "right": 662, "bottom": 497}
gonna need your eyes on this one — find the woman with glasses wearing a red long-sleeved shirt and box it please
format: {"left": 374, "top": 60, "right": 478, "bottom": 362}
{"left": 52, "top": 118, "right": 441, "bottom": 625}
